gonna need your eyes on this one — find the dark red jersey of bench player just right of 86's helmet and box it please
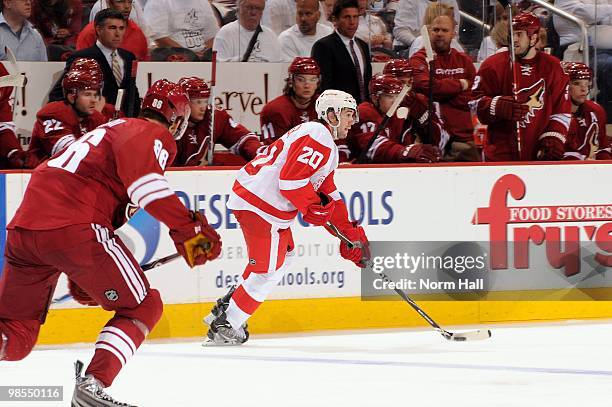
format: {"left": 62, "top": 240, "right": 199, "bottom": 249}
{"left": 172, "top": 107, "right": 262, "bottom": 167}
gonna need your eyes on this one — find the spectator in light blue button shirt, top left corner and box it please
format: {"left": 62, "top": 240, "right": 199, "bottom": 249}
{"left": 0, "top": 0, "right": 47, "bottom": 61}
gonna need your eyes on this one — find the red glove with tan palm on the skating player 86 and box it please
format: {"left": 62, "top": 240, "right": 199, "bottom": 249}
{"left": 170, "top": 212, "right": 221, "bottom": 268}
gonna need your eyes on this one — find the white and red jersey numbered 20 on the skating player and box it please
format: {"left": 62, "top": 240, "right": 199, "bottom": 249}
{"left": 227, "top": 122, "right": 340, "bottom": 228}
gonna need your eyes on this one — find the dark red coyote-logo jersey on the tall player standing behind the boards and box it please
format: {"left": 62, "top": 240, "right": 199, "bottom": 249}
{"left": 472, "top": 51, "right": 571, "bottom": 161}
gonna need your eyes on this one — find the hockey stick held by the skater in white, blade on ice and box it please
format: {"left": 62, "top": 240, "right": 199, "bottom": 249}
{"left": 326, "top": 222, "right": 491, "bottom": 342}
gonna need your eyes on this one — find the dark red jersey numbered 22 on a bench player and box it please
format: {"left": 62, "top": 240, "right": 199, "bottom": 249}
{"left": 28, "top": 101, "right": 107, "bottom": 161}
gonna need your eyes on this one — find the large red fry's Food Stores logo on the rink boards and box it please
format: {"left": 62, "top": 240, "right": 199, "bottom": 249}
{"left": 472, "top": 174, "right": 612, "bottom": 276}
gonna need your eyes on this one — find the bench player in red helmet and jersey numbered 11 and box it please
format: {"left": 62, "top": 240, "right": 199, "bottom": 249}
{"left": 259, "top": 57, "right": 321, "bottom": 144}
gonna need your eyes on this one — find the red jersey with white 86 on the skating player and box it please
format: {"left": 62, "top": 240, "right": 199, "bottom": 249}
{"left": 7, "top": 119, "right": 193, "bottom": 234}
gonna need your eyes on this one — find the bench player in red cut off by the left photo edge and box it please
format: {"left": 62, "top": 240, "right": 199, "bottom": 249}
{"left": 0, "top": 62, "right": 31, "bottom": 170}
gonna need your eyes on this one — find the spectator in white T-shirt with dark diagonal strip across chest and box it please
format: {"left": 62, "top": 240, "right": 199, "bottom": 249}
{"left": 214, "top": 0, "right": 280, "bottom": 62}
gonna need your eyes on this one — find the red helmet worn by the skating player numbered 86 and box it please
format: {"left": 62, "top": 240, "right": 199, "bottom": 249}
{"left": 141, "top": 79, "right": 191, "bottom": 140}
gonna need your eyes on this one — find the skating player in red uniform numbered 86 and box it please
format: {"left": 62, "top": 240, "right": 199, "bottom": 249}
{"left": 0, "top": 80, "right": 221, "bottom": 407}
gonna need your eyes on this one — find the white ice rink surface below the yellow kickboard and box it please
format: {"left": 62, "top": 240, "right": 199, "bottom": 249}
{"left": 0, "top": 321, "right": 612, "bottom": 407}
